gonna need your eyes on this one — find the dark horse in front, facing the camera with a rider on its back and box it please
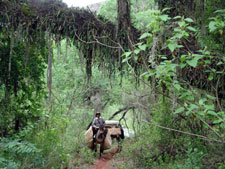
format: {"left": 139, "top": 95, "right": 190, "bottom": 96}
{"left": 92, "top": 124, "right": 108, "bottom": 159}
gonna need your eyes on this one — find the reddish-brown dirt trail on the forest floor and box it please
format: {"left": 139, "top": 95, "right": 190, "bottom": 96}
{"left": 90, "top": 148, "right": 119, "bottom": 169}
